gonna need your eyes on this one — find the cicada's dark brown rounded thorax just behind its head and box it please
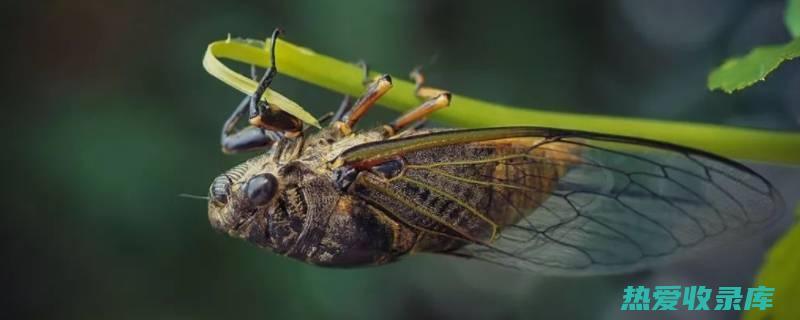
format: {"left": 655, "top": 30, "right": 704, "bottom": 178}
{"left": 267, "top": 171, "right": 410, "bottom": 267}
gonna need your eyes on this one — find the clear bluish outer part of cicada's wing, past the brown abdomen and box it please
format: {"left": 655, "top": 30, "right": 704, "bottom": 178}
{"left": 459, "top": 136, "right": 781, "bottom": 274}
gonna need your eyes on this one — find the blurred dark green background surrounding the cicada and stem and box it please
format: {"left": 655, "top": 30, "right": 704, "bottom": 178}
{"left": 6, "top": 0, "right": 800, "bottom": 319}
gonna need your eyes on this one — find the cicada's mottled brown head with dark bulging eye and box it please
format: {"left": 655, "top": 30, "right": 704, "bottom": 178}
{"left": 208, "top": 157, "right": 282, "bottom": 246}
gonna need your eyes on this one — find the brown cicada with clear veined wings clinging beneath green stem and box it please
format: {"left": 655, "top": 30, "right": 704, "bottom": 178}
{"left": 208, "top": 31, "right": 781, "bottom": 275}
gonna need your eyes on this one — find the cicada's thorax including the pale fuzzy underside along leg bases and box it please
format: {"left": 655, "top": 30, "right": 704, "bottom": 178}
{"left": 264, "top": 131, "right": 416, "bottom": 267}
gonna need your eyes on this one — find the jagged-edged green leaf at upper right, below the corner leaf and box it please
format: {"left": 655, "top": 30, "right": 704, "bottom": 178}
{"left": 708, "top": 38, "right": 800, "bottom": 93}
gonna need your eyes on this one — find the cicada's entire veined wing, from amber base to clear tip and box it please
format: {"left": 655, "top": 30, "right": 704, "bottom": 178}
{"left": 344, "top": 129, "right": 782, "bottom": 275}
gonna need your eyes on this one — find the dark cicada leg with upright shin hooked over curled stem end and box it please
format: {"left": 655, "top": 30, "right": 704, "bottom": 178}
{"left": 249, "top": 29, "right": 303, "bottom": 136}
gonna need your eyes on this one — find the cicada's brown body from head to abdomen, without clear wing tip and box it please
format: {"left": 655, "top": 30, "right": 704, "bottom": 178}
{"left": 209, "top": 126, "right": 574, "bottom": 267}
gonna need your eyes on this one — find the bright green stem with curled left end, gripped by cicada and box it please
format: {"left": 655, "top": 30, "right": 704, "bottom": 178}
{"left": 204, "top": 39, "right": 800, "bottom": 165}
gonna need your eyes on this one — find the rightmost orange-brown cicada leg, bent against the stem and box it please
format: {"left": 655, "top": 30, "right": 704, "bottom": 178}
{"left": 383, "top": 67, "right": 452, "bottom": 137}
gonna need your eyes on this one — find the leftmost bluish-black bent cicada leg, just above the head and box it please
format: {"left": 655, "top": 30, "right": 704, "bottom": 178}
{"left": 220, "top": 97, "right": 282, "bottom": 154}
